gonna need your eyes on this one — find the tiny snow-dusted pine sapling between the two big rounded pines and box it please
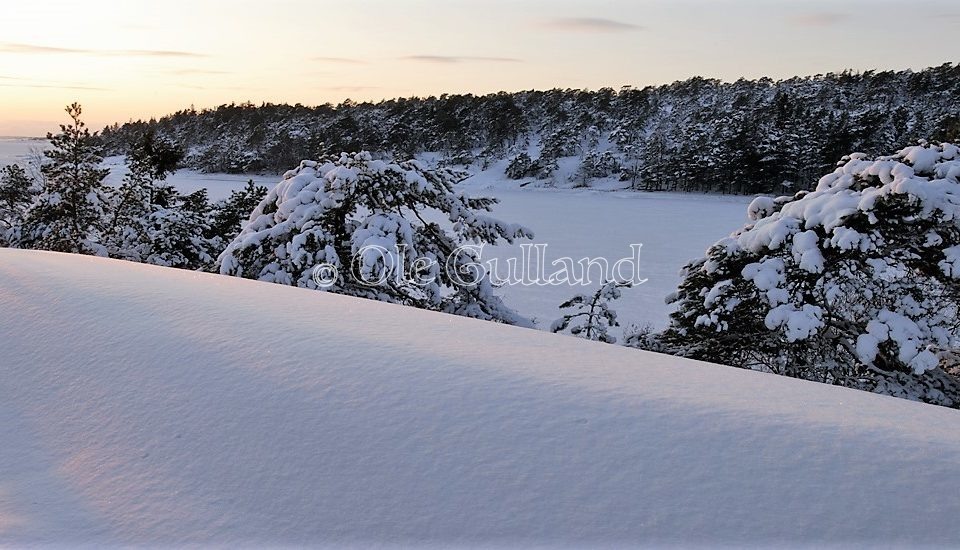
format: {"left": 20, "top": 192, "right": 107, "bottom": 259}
{"left": 550, "top": 281, "right": 631, "bottom": 344}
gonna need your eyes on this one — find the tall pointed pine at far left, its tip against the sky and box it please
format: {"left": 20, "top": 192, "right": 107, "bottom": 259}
{"left": 20, "top": 103, "right": 110, "bottom": 256}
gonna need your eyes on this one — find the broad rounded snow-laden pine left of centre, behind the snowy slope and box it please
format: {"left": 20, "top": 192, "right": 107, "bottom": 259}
{"left": 218, "top": 152, "right": 533, "bottom": 326}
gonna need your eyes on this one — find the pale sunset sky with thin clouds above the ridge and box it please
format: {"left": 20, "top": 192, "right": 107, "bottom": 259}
{"left": 0, "top": 0, "right": 960, "bottom": 136}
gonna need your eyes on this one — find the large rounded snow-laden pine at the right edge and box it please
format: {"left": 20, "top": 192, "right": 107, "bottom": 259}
{"left": 664, "top": 143, "right": 960, "bottom": 407}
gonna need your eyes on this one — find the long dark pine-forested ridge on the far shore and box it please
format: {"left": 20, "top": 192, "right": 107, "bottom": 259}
{"left": 103, "top": 63, "right": 960, "bottom": 193}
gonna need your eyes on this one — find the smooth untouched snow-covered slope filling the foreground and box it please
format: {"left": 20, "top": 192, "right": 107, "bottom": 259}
{"left": 0, "top": 250, "right": 960, "bottom": 546}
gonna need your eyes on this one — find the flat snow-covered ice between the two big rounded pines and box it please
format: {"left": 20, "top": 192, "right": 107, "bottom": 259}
{"left": 478, "top": 189, "right": 750, "bottom": 332}
